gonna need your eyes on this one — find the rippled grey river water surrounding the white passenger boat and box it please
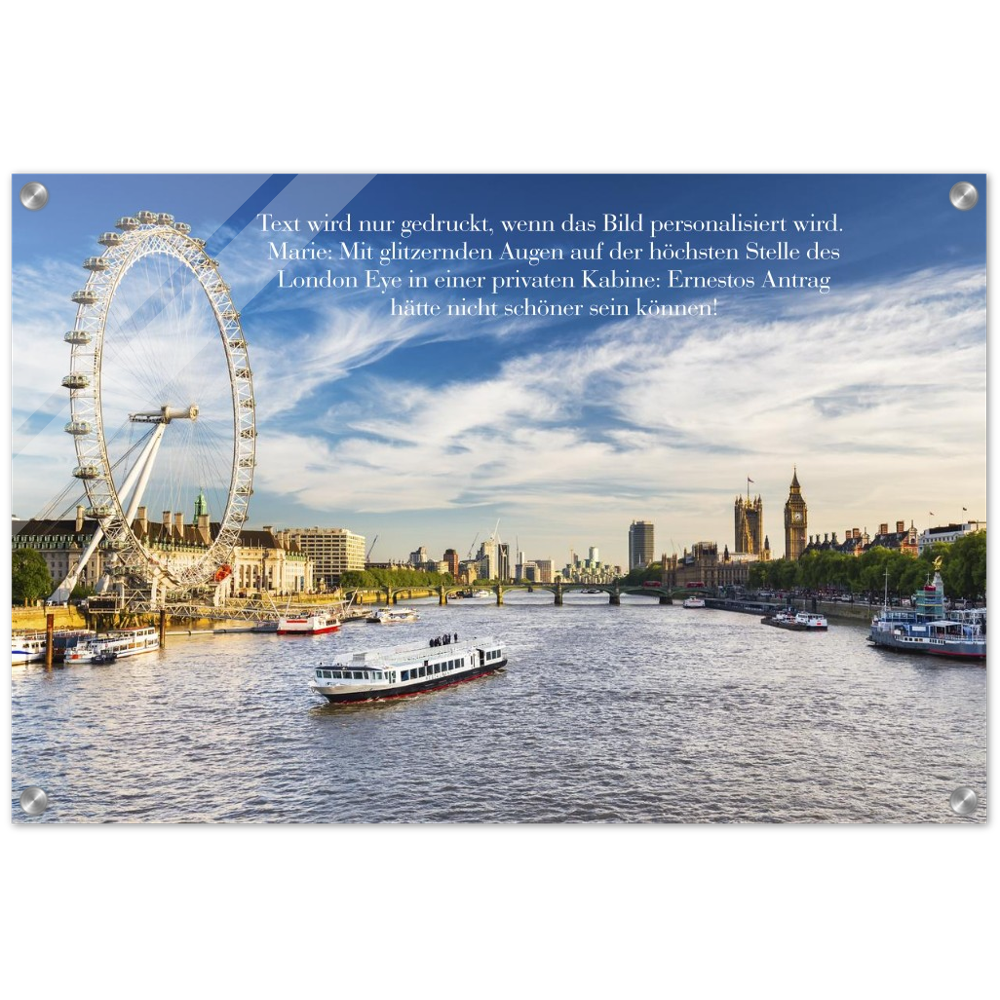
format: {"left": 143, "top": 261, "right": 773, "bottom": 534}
{"left": 11, "top": 593, "right": 986, "bottom": 823}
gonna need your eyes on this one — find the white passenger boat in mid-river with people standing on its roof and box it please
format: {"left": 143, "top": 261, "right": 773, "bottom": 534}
{"left": 309, "top": 633, "right": 507, "bottom": 704}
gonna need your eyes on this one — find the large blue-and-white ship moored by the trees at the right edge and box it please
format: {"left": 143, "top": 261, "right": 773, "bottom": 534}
{"left": 868, "top": 564, "right": 986, "bottom": 660}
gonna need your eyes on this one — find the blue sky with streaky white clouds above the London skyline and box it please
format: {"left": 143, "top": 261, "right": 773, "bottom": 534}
{"left": 11, "top": 172, "right": 986, "bottom": 565}
